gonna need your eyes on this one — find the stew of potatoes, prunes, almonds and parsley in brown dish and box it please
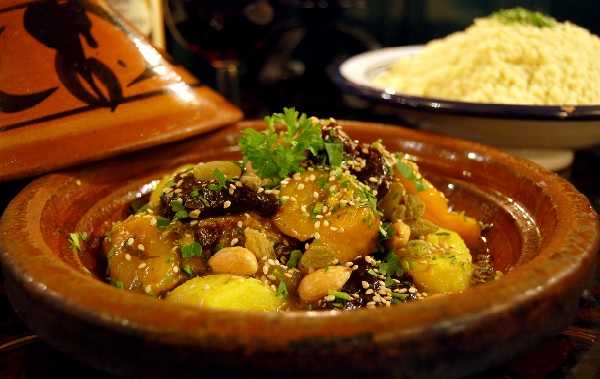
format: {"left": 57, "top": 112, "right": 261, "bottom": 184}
{"left": 94, "top": 109, "right": 499, "bottom": 311}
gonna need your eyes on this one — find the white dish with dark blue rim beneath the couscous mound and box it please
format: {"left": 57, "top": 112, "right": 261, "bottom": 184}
{"left": 334, "top": 46, "right": 600, "bottom": 168}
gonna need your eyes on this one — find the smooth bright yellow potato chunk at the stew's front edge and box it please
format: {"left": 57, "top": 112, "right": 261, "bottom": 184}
{"left": 166, "top": 275, "right": 284, "bottom": 311}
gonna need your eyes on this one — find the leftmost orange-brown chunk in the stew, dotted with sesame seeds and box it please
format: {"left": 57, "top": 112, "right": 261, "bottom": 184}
{"left": 104, "top": 215, "right": 184, "bottom": 296}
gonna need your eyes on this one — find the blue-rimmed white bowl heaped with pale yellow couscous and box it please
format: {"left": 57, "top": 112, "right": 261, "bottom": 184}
{"left": 335, "top": 9, "right": 600, "bottom": 169}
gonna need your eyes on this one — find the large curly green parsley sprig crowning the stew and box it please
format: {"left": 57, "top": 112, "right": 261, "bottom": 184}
{"left": 240, "top": 108, "right": 325, "bottom": 182}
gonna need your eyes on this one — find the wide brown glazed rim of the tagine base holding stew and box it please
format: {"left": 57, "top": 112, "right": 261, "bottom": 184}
{"left": 0, "top": 122, "right": 599, "bottom": 374}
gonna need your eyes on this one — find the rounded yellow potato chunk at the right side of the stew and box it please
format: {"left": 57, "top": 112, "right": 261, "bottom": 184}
{"left": 397, "top": 228, "right": 473, "bottom": 293}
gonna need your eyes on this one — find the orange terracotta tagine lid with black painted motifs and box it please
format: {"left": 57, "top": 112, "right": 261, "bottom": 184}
{"left": 0, "top": 0, "right": 242, "bottom": 182}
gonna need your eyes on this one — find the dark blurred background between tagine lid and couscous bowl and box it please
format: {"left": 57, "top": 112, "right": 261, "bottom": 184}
{"left": 109, "top": 0, "right": 600, "bottom": 121}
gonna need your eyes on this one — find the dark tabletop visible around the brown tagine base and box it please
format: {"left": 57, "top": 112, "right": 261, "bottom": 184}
{"left": 0, "top": 148, "right": 600, "bottom": 379}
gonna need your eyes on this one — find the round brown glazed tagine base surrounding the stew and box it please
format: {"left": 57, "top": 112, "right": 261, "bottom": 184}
{"left": 0, "top": 122, "right": 599, "bottom": 378}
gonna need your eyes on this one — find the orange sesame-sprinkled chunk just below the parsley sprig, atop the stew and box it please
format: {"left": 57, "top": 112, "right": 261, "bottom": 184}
{"left": 274, "top": 170, "right": 379, "bottom": 262}
